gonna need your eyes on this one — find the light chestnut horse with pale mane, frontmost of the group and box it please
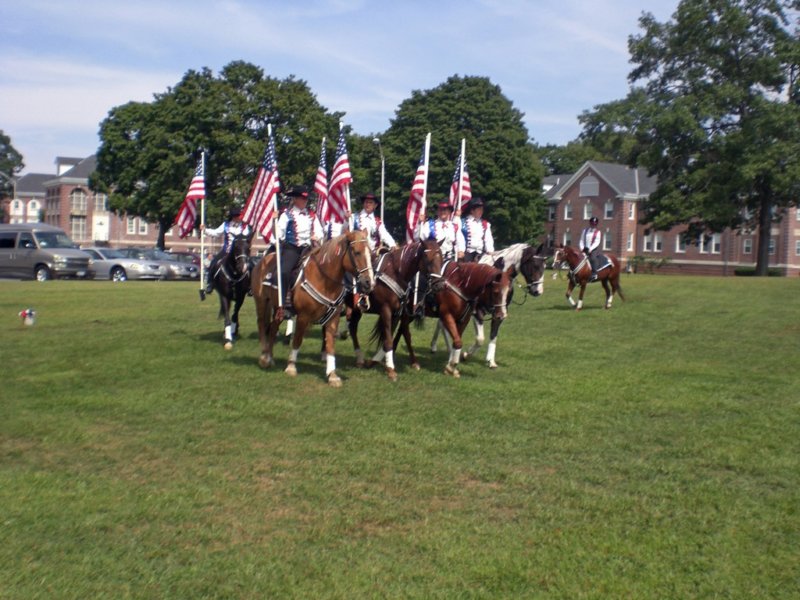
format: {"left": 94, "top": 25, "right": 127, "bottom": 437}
{"left": 252, "top": 231, "right": 375, "bottom": 387}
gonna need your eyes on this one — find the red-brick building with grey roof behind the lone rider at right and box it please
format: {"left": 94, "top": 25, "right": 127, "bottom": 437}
{"left": 544, "top": 161, "right": 800, "bottom": 275}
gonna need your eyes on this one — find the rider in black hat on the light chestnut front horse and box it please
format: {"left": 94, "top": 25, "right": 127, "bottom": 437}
{"left": 278, "top": 185, "right": 323, "bottom": 319}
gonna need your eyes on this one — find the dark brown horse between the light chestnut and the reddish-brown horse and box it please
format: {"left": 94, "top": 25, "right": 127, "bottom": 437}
{"left": 348, "top": 240, "right": 442, "bottom": 381}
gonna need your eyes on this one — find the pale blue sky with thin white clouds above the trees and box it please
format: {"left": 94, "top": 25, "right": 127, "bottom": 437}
{"left": 0, "top": 0, "right": 678, "bottom": 173}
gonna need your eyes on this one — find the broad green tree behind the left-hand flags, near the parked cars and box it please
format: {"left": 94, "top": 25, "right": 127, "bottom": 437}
{"left": 92, "top": 61, "right": 341, "bottom": 247}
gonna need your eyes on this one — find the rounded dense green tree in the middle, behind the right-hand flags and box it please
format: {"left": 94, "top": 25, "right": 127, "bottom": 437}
{"left": 380, "top": 76, "right": 544, "bottom": 244}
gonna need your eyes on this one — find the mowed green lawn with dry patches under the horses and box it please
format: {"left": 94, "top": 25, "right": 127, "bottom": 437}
{"left": 0, "top": 275, "right": 800, "bottom": 599}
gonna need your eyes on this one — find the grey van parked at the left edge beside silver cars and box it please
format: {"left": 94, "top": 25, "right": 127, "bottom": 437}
{"left": 0, "top": 223, "right": 93, "bottom": 281}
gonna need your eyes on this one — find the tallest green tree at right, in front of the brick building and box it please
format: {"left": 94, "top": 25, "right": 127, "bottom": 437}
{"left": 583, "top": 0, "right": 800, "bottom": 275}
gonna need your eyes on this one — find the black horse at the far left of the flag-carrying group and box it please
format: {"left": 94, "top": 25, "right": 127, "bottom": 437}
{"left": 209, "top": 234, "right": 253, "bottom": 350}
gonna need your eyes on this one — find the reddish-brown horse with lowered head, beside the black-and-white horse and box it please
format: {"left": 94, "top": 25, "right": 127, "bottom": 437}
{"left": 394, "top": 262, "right": 511, "bottom": 377}
